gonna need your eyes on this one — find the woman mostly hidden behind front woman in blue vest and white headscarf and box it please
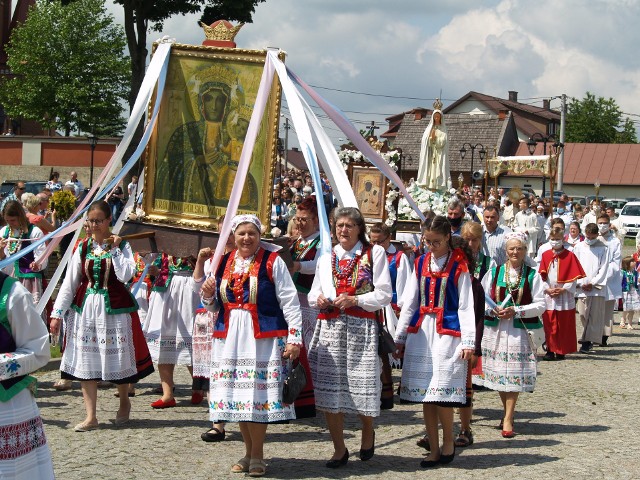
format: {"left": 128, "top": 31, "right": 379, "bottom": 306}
{"left": 191, "top": 215, "right": 236, "bottom": 442}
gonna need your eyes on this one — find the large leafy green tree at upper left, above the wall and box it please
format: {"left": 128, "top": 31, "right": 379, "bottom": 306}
{"left": 0, "top": 0, "right": 130, "bottom": 136}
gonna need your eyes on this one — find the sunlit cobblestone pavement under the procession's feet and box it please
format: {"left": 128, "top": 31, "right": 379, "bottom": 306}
{"left": 38, "top": 315, "right": 640, "bottom": 480}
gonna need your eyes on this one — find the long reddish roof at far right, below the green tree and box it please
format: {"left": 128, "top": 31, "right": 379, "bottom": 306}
{"left": 516, "top": 143, "right": 640, "bottom": 185}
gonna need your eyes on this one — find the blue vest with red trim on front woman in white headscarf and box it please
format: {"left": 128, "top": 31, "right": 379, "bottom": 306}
{"left": 213, "top": 248, "right": 288, "bottom": 338}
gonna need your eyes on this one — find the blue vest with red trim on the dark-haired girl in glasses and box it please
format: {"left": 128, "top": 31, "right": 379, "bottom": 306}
{"left": 407, "top": 248, "right": 469, "bottom": 337}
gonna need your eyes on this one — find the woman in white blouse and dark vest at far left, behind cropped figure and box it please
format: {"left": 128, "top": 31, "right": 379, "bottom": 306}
{"left": 0, "top": 200, "right": 47, "bottom": 310}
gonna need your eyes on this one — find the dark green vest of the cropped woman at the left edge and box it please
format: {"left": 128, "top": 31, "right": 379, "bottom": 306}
{"left": 0, "top": 272, "right": 36, "bottom": 402}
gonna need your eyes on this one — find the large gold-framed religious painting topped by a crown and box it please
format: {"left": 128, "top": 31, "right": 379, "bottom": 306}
{"left": 143, "top": 44, "right": 285, "bottom": 229}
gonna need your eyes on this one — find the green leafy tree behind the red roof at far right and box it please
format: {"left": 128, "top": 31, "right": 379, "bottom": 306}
{"left": 566, "top": 92, "right": 638, "bottom": 143}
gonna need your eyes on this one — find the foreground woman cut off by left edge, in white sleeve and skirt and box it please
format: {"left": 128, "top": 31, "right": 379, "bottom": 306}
{"left": 0, "top": 272, "right": 54, "bottom": 480}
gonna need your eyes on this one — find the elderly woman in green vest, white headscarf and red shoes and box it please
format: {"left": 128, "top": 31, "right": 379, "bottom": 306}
{"left": 482, "top": 232, "right": 545, "bottom": 438}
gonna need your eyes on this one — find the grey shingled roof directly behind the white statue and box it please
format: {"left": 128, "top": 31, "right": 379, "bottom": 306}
{"left": 393, "top": 114, "right": 513, "bottom": 171}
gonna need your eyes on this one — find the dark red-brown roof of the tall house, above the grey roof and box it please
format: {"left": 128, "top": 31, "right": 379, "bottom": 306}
{"left": 443, "top": 91, "right": 560, "bottom": 136}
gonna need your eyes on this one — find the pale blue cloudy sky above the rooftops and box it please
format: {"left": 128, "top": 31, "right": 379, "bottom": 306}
{"left": 107, "top": 0, "right": 640, "bottom": 143}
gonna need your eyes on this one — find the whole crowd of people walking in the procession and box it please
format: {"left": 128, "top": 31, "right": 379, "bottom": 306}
{"left": 0, "top": 167, "right": 640, "bottom": 478}
